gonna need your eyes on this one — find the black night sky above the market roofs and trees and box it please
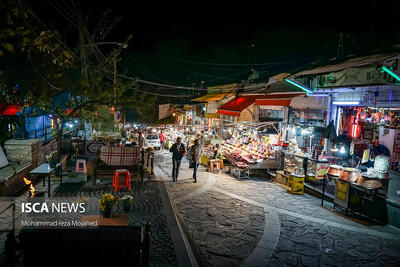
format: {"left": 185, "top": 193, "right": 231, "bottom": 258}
{"left": 23, "top": 0, "right": 400, "bottom": 89}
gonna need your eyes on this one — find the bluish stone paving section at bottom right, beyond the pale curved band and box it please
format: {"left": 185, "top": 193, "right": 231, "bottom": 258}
{"left": 270, "top": 214, "right": 400, "bottom": 266}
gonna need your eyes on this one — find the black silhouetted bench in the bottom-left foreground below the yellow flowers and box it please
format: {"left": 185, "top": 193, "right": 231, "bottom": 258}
{"left": 6, "top": 224, "right": 150, "bottom": 267}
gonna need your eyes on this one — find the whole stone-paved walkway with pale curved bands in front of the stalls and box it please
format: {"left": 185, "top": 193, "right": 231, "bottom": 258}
{"left": 156, "top": 151, "right": 400, "bottom": 266}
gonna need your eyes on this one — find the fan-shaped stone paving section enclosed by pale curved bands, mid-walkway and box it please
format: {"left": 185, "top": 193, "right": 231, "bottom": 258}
{"left": 177, "top": 192, "right": 264, "bottom": 266}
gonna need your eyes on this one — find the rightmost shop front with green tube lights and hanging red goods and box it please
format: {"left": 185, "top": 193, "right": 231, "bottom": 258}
{"left": 285, "top": 55, "right": 400, "bottom": 226}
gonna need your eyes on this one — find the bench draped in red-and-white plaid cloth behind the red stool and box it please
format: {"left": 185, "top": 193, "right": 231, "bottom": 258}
{"left": 93, "top": 146, "right": 144, "bottom": 183}
